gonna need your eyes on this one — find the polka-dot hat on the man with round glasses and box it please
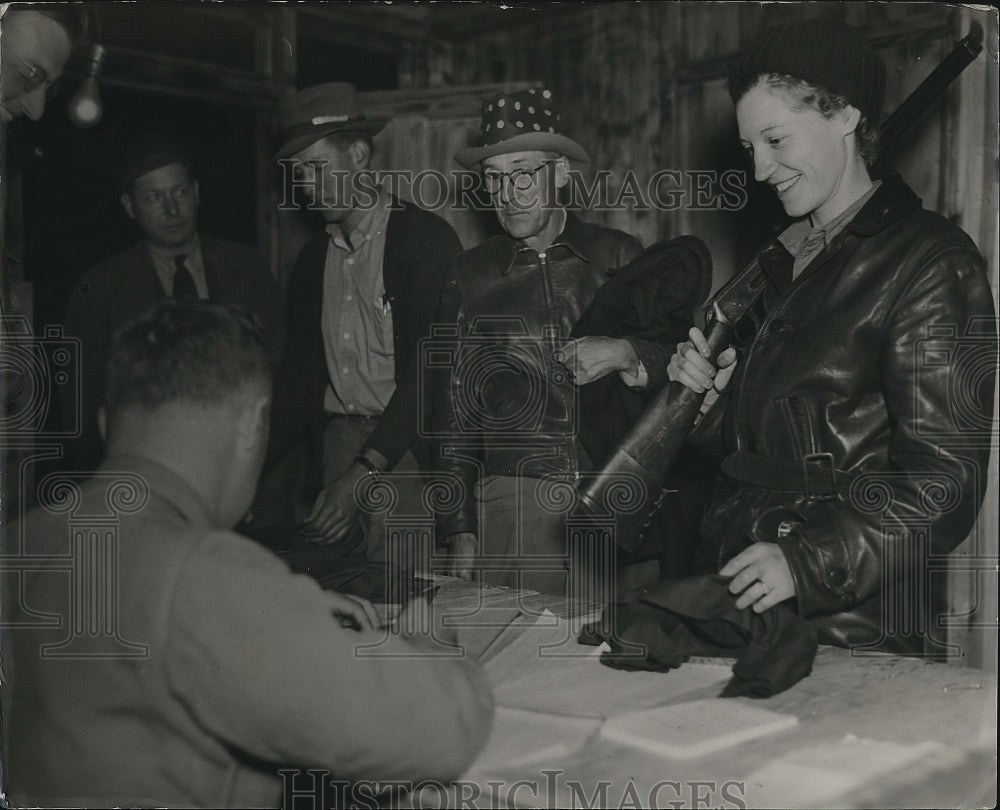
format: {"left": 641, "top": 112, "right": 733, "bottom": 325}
{"left": 455, "top": 87, "right": 590, "bottom": 169}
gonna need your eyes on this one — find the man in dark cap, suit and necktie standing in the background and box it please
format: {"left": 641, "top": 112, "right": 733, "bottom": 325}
{"left": 63, "top": 135, "right": 281, "bottom": 469}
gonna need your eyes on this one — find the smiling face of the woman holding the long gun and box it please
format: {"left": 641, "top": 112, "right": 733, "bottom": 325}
{"left": 736, "top": 82, "right": 857, "bottom": 222}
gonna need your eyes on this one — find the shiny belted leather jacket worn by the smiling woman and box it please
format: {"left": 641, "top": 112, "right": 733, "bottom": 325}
{"left": 693, "top": 176, "right": 997, "bottom": 653}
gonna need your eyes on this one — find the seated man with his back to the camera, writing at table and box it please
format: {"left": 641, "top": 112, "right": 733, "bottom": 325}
{"left": 9, "top": 300, "right": 492, "bottom": 807}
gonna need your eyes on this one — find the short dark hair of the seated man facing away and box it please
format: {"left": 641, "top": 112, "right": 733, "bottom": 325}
{"left": 104, "top": 299, "right": 271, "bottom": 417}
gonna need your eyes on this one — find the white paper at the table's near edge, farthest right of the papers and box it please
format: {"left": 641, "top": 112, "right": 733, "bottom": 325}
{"left": 745, "top": 734, "right": 946, "bottom": 807}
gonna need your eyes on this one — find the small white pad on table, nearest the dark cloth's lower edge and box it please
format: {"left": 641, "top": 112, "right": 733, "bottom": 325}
{"left": 601, "top": 698, "right": 799, "bottom": 760}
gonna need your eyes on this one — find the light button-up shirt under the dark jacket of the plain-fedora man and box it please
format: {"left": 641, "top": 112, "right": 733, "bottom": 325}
{"left": 323, "top": 194, "right": 396, "bottom": 416}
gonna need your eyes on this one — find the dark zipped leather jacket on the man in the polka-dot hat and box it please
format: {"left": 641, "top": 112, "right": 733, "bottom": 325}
{"left": 434, "top": 213, "right": 644, "bottom": 536}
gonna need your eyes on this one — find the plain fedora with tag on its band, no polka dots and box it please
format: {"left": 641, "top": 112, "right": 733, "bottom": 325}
{"left": 274, "top": 82, "right": 389, "bottom": 159}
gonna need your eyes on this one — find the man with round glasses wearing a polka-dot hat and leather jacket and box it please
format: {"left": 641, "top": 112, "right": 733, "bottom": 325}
{"left": 432, "top": 88, "right": 669, "bottom": 598}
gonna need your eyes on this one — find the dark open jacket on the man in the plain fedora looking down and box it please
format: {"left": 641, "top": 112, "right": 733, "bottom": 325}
{"left": 270, "top": 200, "right": 462, "bottom": 476}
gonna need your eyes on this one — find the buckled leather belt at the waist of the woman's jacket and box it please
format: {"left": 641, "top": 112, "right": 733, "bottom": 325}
{"left": 722, "top": 451, "right": 857, "bottom": 500}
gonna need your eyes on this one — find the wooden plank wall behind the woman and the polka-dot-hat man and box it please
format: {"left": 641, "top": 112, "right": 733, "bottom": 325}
{"left": 451, "top": 3, "right": 1000, "bottom": 670}
